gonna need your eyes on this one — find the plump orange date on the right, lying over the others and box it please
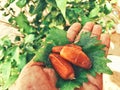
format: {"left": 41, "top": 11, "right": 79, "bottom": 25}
{"left": 60, "top": 44, "right": 91, "bottom": 69}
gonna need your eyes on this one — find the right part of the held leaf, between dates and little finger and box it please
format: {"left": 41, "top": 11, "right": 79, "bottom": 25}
{"left": 77, "top": 33, "right": 112, "bottom": 74}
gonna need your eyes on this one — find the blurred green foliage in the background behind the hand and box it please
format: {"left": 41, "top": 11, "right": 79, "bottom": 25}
{"left": 0, "top": 0, "right": 115, "bottom": 90}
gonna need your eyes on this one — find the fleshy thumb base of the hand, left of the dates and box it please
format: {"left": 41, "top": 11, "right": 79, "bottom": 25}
{"left": 9, "top": 60, "right": 57, "bottom": 90}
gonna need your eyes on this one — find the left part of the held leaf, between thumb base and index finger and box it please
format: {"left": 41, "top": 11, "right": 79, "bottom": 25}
{"left": 33, "top": 28, "right": 69, "bottom": 66}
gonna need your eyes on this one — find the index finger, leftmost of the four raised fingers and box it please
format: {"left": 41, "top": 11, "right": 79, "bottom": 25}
{"left": 67, "top": 22, "right": 81, "bottom": 42}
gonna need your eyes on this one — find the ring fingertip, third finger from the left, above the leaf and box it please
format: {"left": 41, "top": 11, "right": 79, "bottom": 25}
{"left": 91, "top": 25, "right": 102, "bottom": 39}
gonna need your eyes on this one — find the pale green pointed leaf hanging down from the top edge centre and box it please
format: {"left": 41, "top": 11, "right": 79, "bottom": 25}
{"left": 55, "top": 0, "right": 67, "bottom": 18}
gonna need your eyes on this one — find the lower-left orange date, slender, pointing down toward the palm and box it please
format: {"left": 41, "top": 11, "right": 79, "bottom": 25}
{"left": 49, "top": 53, "right": 75, "bottom": 80}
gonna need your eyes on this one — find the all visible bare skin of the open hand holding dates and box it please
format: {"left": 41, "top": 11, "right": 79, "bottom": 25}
{"left": 9, "top": 22, "right": 110, "bottom": 90}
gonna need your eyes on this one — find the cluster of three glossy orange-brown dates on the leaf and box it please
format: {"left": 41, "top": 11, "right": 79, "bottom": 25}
{"left": 49, "top": 44, "right": 92, "bottom": 80}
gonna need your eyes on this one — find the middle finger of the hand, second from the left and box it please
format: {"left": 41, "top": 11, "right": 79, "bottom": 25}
{"left": 75, "top": 22, "right": 94, "bottom": 42}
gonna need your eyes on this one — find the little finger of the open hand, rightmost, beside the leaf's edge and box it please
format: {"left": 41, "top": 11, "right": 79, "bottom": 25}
{"left": 100, "top": 34, "right": 110, "bottom": 55}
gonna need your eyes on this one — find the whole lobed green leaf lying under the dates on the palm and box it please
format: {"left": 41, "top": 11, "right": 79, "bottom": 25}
{"left": 33, "top": 28, "right": 112, "bottom": 90}
